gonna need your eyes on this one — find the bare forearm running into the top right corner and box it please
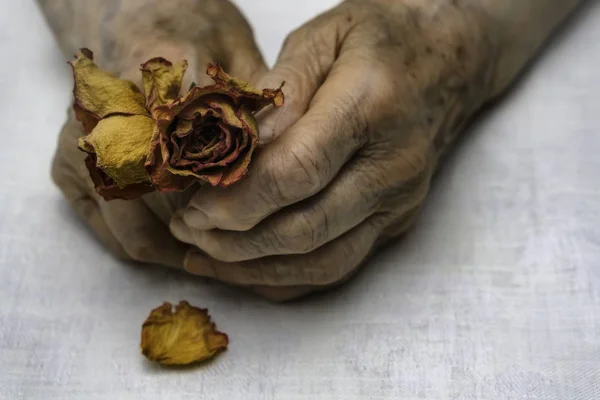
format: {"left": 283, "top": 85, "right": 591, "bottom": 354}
{"left": 480, "top": 0, "right": 585, "bottom": 95}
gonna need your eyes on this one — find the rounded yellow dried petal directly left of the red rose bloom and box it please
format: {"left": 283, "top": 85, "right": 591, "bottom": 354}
{"left": 79, "top": 115, "right": 154, "bottom": 188}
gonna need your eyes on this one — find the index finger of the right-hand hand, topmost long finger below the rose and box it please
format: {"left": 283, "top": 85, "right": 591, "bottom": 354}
{"left": 185, "top": 62, "right": 369, "bottom": 231}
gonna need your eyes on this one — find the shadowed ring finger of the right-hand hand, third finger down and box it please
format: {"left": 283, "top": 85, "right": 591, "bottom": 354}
{"left": 184, "top": 216, "right": 384, "bottom": 286}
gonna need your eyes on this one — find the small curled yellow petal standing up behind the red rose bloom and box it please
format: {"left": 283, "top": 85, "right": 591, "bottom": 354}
{"left": 141, "top": 57, "right": 187, "bottom": 109}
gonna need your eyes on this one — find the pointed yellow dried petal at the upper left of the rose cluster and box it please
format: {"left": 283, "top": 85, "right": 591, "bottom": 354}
{"left": 69, "top": 49, "right": 149, "bottom": 126}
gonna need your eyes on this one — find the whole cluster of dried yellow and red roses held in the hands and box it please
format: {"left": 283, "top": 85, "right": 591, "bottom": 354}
{"left": 70, "top": 49, "right": 283, "bottom": 200}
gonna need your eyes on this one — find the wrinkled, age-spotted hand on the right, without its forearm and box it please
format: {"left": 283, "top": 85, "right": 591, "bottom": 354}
{"left": 171, "top": 0, "right": 493, "bottom": 298}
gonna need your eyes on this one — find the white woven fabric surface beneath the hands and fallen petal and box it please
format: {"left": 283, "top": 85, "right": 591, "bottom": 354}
{"left": 0, "top": 0, "right": 600, "bottom": 400}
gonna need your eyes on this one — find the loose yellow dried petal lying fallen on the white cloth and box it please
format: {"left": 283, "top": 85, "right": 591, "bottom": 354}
{"left": 141, "top": 301, "right": 229, "bottom": 365}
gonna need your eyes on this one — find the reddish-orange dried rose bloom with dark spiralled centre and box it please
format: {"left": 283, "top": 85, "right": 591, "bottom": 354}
{"left": 143, "top": 61, "right": 283, "bottom": 191}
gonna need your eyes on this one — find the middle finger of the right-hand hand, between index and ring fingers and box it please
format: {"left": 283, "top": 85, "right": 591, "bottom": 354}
{"left": 171, "top": 143, "right": 429, "bottom": 262}
